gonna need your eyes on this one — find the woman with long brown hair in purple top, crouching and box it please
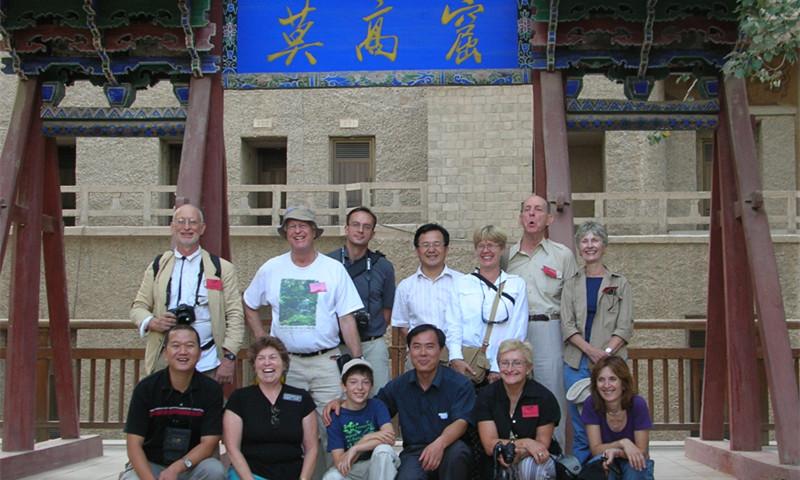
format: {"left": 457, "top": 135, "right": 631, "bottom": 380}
{"left": 581, "top": 356, "right": 653, "bottom": 480}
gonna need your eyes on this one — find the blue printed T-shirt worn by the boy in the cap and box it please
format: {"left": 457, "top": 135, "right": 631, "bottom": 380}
{"left": 328, "top": 398, "right": 392, "bottom": 457}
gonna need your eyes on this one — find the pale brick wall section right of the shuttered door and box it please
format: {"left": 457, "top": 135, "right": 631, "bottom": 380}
{"left": 427, "top": 86, "right": 532, "bottom": 239}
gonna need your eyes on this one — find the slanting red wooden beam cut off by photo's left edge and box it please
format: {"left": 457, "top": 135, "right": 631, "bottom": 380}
{"left": 0, "top": 80, "right": 39, "bottom": 271}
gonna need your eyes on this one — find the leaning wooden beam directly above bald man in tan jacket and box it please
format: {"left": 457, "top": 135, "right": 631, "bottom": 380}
{"left": 175, "top": 76, "right": 211, "bottom": 207}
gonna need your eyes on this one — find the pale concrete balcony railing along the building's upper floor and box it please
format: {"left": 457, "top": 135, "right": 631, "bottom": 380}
{"left": 53, "top": 182, "right": 800, "bottom": 235}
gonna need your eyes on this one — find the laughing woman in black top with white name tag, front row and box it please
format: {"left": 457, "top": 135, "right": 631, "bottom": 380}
{"left": 222, "top": 336, "right": 318, "bottom": 480}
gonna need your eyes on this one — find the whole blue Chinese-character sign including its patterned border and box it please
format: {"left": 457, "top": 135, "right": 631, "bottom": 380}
{"left": 223, "top": 0, "right": 530, "bottom": 89}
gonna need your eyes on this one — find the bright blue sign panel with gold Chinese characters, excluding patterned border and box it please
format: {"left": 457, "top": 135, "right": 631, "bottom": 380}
{"left": 238, "top": 0, "right": 519, "bottom": 73}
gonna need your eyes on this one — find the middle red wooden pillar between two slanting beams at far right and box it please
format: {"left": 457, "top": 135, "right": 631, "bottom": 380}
{"left": 716, "top": 95, "right": 761, "bottom": 450}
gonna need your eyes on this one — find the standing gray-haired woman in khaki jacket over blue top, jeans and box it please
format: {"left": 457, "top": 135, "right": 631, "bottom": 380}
{"left": 561, "top": 221, "right": 633, "bottom": 463}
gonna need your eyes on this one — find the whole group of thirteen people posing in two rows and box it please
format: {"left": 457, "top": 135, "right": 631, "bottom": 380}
{"left": 121, "top": 195, "right": 653, "bottom": 480}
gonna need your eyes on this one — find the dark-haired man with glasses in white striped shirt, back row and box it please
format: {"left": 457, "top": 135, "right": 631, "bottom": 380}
{"left": 392, "top": 223, "right": 463, "bottom": 366}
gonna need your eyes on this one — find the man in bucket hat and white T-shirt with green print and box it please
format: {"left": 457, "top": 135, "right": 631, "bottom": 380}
{"left": 244, "top": 207, "right": 364, "bottom": 478}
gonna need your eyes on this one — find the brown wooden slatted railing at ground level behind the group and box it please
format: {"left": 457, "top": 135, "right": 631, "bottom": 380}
{"left": 0, "top": 320, "right": 800, "bottom": 440}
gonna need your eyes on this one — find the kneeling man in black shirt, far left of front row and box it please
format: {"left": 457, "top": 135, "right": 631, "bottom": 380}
{"left": 120, "top": 325, "right": 225, "bottom": 480}
